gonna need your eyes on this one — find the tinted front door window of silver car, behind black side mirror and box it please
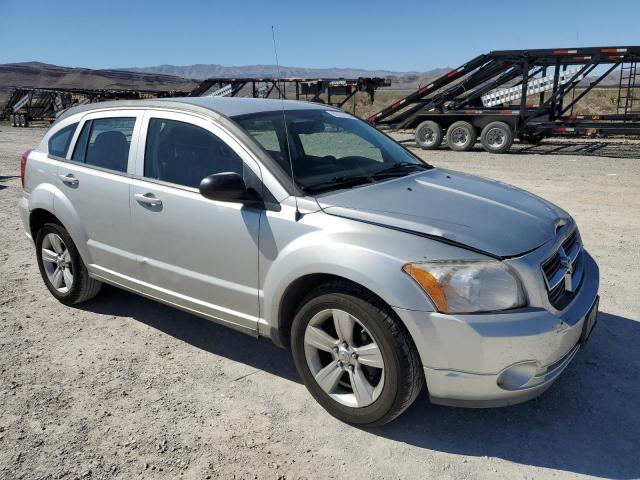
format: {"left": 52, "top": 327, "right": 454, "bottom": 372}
{"left": 144, "top": 118, "right": 243, "bottom": 188}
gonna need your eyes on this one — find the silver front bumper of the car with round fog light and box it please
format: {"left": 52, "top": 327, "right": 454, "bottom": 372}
{"left": 395, "top": 251, "right": 599, "bottom": 407}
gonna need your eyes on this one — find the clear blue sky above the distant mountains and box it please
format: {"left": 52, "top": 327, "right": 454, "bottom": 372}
{"left": 0, "top": 0, "right": 640, "bottom": 71}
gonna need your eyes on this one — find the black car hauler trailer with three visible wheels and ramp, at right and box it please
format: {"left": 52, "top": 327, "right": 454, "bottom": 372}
{"left": 368, "top": 46, "right": 640, "bottom": 153}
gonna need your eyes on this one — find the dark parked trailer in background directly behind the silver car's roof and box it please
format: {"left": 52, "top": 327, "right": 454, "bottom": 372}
{"left": 189, "top": 77, "right": 391, "bottom": 108}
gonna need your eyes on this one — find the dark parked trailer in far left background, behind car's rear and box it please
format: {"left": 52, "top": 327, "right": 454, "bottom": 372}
{"left": 0, "top": 87, "right": 189, "bottom": 127}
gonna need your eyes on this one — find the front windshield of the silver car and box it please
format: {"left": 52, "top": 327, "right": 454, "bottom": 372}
{"left": 233, "top": 109, "right": 430, "bottom": 194}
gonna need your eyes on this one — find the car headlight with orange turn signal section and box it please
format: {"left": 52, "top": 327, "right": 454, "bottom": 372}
{"left": 402, "top": 261, "right": 525, "bottom": 313}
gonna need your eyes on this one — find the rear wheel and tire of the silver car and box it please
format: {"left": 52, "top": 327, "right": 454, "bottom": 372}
{"left": 36, "top": 223, "right": 102, "bottom": 305}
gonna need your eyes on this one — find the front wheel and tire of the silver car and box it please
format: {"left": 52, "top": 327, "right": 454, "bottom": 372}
{"left": 291, "top": 281, "right": 424, "bottom": 427}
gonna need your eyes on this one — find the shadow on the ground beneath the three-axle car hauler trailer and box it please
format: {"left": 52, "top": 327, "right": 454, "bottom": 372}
{"left": 400, "top": 139, "right": 640, "bottom": 158}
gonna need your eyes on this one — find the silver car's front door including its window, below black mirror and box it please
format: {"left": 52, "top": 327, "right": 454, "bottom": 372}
{"left": 131, "top": 111, "right": 263, "bottom": 331}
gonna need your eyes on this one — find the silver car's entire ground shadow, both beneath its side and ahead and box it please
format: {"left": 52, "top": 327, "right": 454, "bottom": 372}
{"left": 80, "top": 286, "right": 640, "bottom": 479}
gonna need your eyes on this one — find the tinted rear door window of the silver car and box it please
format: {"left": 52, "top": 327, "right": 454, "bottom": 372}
{"left": 71, "top": 117, "right": 136, "bottom": 173}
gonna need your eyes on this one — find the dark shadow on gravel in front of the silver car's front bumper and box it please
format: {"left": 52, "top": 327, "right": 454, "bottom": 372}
{"left": 372, "top": 313, "right": 640, "bottom": 479}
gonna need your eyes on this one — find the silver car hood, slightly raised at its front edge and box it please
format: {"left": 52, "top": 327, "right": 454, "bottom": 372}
{"left": 317, "top": 168, "right": 571, "bottom": 257}
